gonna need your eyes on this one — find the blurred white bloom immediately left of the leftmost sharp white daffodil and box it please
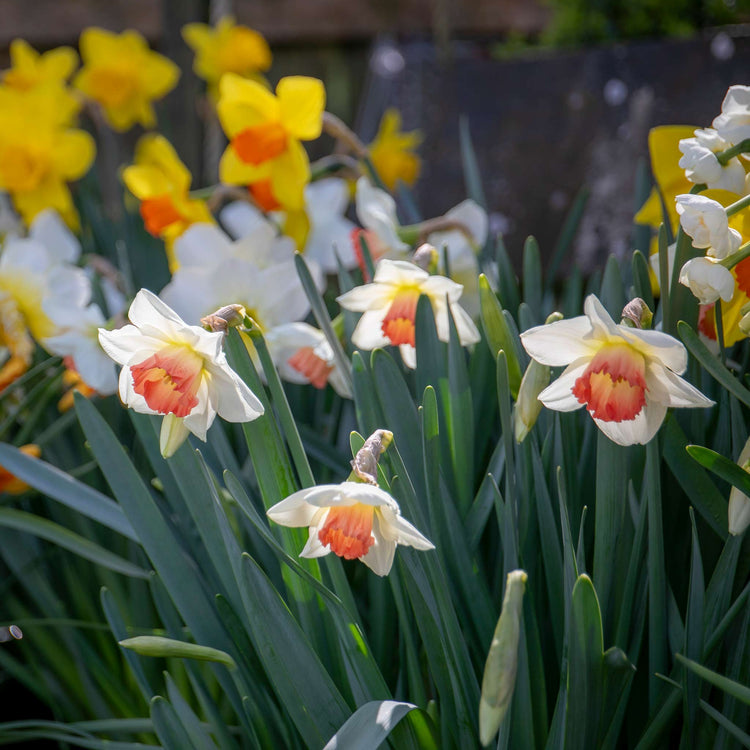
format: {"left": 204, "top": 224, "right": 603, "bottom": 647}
{"left": 45, "top": 305, "right": 117, "bottom": 396}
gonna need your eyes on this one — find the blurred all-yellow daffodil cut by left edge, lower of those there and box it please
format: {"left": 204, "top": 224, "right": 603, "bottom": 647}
{"left": 0, "top": 91, "right": 96, "bottom": 229}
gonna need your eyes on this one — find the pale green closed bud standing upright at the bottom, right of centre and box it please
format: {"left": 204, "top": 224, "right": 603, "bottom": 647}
{"left": 479, "top": 570, "right": 528, "bottom": 745}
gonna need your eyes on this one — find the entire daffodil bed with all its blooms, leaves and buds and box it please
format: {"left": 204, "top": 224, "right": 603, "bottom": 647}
{"left": 0, "top": 23, "right": 750, "bottom": 750}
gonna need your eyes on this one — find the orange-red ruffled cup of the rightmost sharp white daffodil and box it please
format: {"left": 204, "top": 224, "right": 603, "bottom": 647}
{"left": 572, "top": 344, "right": 646, "bottom": 422}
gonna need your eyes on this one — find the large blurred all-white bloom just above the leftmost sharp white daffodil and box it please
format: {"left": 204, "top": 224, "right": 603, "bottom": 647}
{"left": 160, "top": 223, "right": 322, "bottom": 334}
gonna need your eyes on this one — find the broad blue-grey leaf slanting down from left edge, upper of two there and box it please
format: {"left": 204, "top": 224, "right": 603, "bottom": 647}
{"left": 0, "top": 444, "right": 138, "bottom": 542}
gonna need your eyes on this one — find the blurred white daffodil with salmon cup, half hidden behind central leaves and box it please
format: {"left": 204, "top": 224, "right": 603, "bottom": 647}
{"left": 264, "top": 323, "right": 352, "bottom": 398}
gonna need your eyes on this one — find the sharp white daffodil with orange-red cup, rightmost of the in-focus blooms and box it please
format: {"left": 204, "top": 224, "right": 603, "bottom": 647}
{"left": 521, "top": 294, "right": 713, "bottom": 445}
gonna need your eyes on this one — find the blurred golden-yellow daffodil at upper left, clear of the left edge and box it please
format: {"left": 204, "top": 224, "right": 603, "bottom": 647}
{"left": 74, "top": 28, "right": 180, "bottom": 131}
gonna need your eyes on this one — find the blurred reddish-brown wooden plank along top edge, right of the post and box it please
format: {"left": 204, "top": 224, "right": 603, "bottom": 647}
{"left": 235, "top": 0, "right": 551, "bottom": 43}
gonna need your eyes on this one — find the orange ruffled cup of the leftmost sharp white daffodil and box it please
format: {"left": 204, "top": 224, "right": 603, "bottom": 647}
{"left": 130, "top": 345, "right": 203, "bottom": 417}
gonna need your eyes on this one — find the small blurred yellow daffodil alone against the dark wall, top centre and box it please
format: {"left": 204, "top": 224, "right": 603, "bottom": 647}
{"left": 370, "top": 109, "right": 422, "bottom": 191}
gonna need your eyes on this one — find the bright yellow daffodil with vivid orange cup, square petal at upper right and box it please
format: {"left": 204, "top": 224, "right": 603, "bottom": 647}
{"left": 217, "top": 73, "right": 325, "bottom": 210}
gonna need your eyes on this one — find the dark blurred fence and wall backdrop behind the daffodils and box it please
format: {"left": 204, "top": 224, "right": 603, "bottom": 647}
{"left": 0, "top": 0, "right": 750, "bottom": 269}
